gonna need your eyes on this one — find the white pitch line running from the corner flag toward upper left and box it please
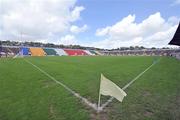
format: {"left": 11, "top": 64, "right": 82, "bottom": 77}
{"left": 24, "top": 59, "right": 98, "bottom": 111}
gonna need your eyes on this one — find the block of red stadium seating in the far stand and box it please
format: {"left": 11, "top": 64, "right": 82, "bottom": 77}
{"left": 64, "top": 49, "right": 88, "bottom": 56}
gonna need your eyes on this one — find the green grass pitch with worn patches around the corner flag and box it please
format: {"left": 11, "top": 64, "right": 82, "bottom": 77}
{"left": 0, "top": 56, "right": 180, "bottom": 120}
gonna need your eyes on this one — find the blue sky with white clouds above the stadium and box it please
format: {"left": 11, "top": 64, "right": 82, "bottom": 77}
{"left": 0, "top": 0, "right": 180, "bottom": 49}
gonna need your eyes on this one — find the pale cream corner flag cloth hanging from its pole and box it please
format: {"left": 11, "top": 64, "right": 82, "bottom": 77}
{"left": 100, "top": 74, "right": 127, "bottom": 102}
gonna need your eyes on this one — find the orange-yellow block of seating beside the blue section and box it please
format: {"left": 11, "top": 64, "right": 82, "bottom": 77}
{"left": 30, "top": 48, "right": 46, "bottom": 56}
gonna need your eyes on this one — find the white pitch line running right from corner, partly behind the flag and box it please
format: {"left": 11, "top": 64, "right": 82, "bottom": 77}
{"left": 99, "top": 60, "right": 159, "bottom": 111}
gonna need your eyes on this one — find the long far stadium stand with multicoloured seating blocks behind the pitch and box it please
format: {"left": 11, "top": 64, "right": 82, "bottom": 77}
{"left": 0, "top": 46, "right": 180, "bottom": 59}
